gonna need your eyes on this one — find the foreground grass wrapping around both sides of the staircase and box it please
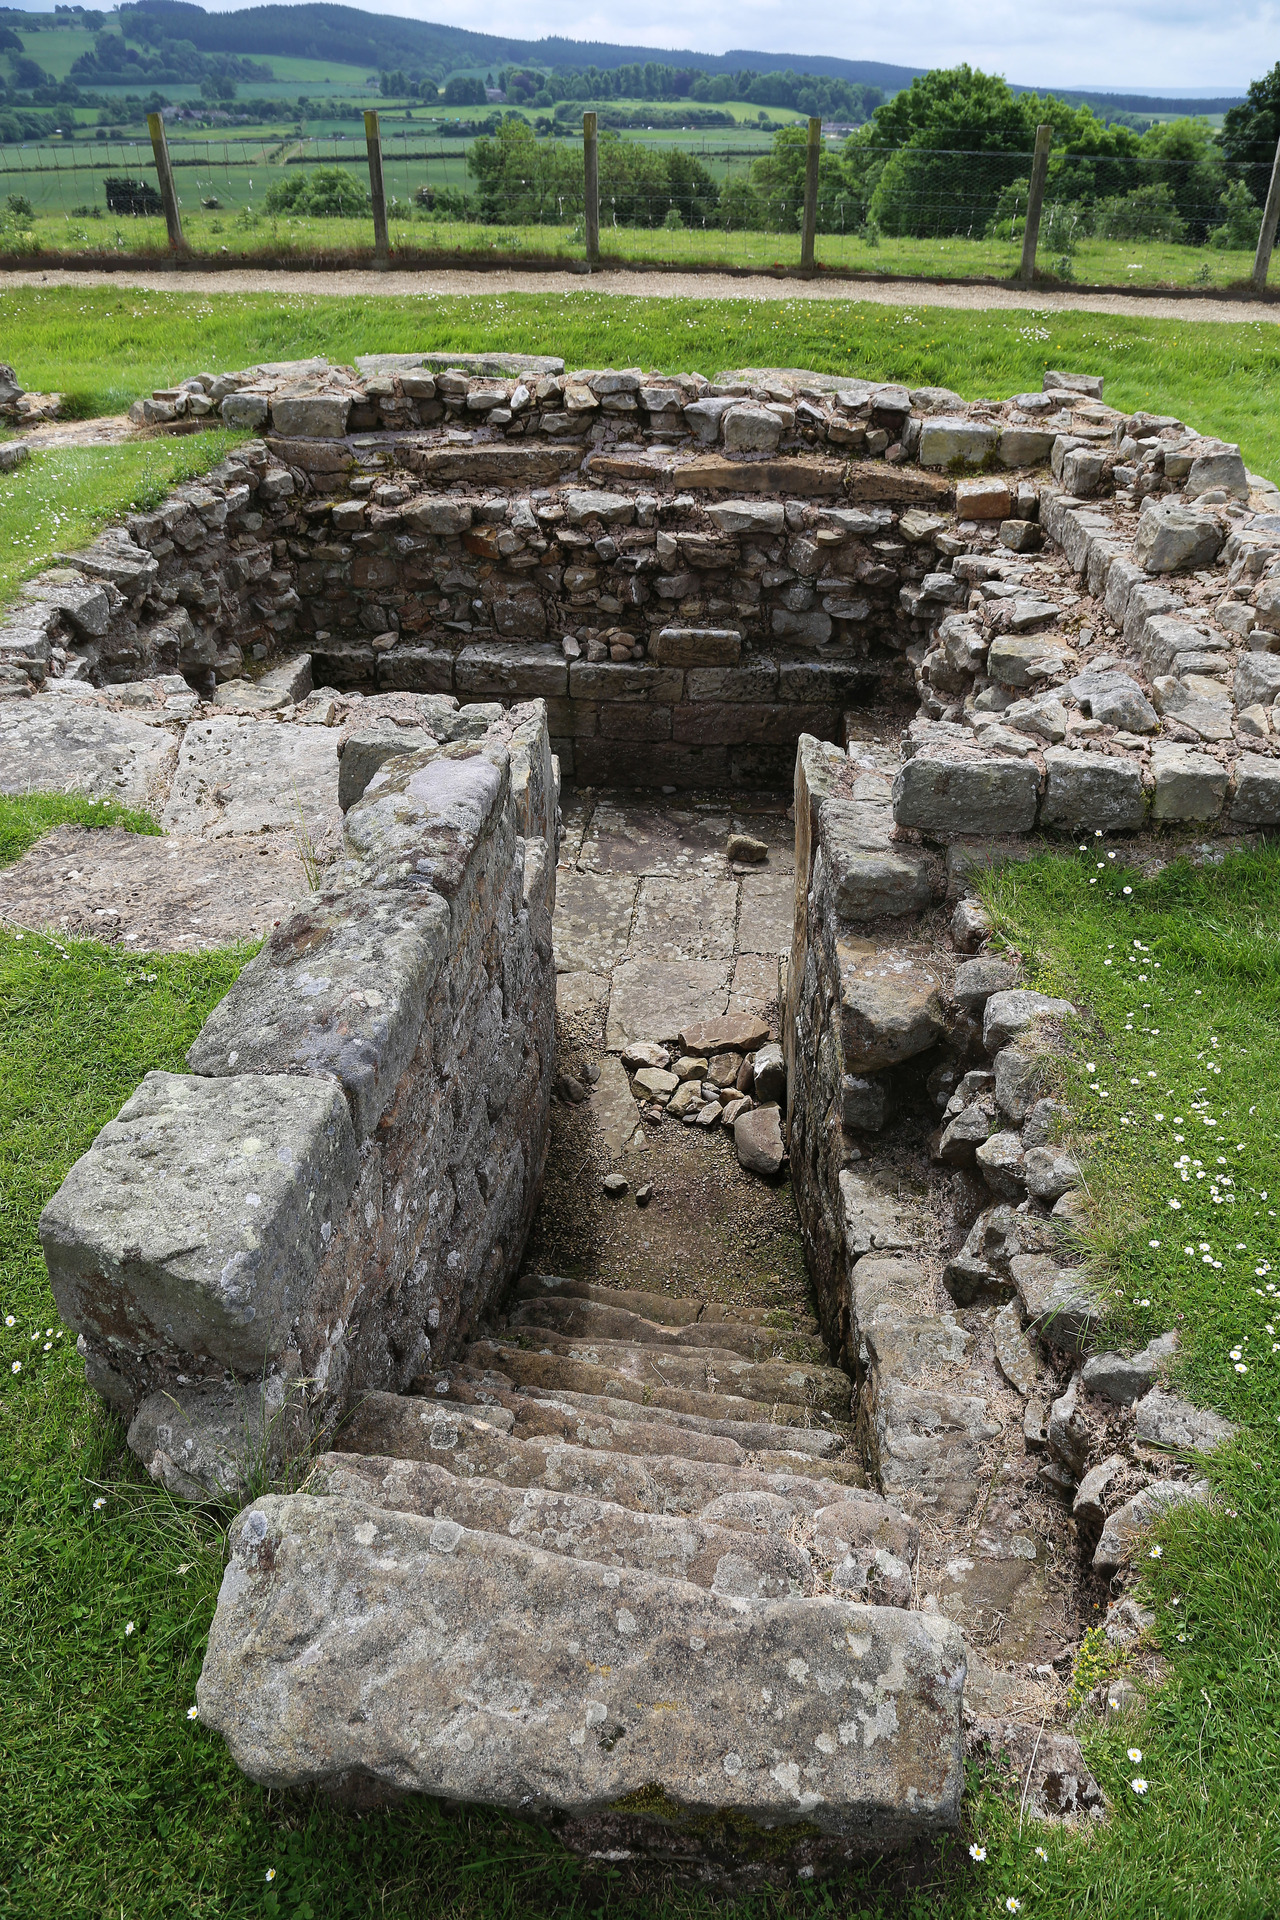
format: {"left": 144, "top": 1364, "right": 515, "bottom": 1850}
{"left": 0, "top": 797, "right": 1280, "bottom": 1920}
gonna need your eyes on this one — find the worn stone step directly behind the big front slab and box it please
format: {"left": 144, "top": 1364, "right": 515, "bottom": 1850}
{"left": 305, "top": 1453, "right": 817, "bottom": 1599}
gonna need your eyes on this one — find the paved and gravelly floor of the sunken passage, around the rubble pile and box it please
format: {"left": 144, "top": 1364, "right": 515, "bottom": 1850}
{"left": 524, "top": 787, "right": 810, "bottom": 1313}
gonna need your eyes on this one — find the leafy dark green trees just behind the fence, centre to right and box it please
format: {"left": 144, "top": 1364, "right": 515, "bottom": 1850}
{"left": 449, "top": 63, "right": 1280, "bottom": 253}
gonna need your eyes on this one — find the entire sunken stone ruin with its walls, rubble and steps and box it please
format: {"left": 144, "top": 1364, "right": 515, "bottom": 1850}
{"left": 14, "top": 355, "right": 1280, "bottom": 1887}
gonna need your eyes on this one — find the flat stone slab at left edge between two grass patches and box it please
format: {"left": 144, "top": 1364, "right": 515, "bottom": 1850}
{"left": 0, "top": 828, "right": 307, "bottom": 952}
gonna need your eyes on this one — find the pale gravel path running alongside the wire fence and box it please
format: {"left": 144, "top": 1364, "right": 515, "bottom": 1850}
{"left": 0, "top": 267, "right": 1280, "bottom": 326}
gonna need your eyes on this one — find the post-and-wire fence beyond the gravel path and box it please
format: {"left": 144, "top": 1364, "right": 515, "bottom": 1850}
{"left": 0, "top": 123, "right": 1272, "bottom": 288}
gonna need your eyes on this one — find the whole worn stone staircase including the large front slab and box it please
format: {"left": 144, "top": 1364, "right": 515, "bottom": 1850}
{"left": 200, "top": 1277, "right": 965, "bottom": 1887}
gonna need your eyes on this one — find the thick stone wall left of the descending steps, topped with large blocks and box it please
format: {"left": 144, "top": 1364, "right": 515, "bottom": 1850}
{"left": 40, "top": 705, "right": 558, "bottom": 1498}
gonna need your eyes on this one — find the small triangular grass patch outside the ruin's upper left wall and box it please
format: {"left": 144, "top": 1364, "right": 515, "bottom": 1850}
{"left": 0, "top": 435, "right": 244, "bottom": 605}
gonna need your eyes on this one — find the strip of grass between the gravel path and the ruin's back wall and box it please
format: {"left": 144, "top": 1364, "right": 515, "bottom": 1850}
{"left": 4, "top": 284, "right": 1280, "bottom": 486}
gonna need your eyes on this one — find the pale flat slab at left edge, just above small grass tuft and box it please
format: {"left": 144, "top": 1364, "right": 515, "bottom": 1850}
{"left": 0, "top": 693, "right": 178, "bottom": 806}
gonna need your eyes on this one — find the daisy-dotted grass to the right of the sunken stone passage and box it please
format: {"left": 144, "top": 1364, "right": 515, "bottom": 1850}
{"left": 975, "top": 847, "right": 1280, "bottom": 1920}
